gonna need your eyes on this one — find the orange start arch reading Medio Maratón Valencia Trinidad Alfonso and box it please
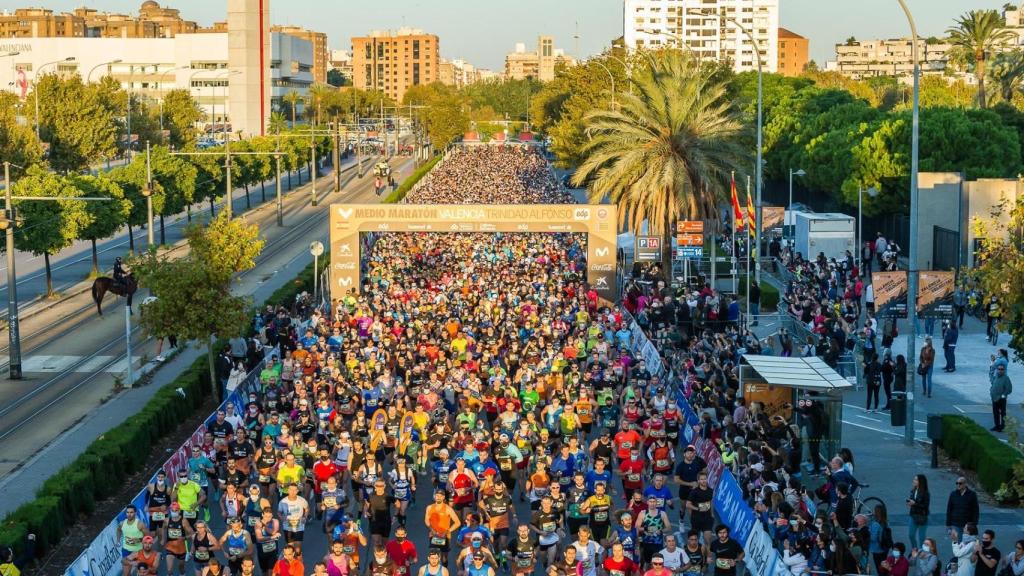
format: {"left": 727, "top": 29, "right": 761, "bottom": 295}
{"left": 330, "top": 204, "right": 618, "bottom": 302}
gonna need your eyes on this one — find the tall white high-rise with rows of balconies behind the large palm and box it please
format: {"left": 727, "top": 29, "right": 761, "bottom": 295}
{"left": 623, "top": 0, "right": 778, "bottom": 72}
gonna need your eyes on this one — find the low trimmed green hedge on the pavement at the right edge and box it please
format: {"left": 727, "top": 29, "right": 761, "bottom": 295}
{"left": 941, "top": 414, "right": 1024, "bottom": 494}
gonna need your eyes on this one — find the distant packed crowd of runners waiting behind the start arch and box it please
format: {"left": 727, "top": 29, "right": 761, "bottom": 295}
{"left": 406, "top": 145, "right": 574, "bottom": 204}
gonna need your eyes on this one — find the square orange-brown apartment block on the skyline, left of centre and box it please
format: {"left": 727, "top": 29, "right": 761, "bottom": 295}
{"left": 352, "top": 28, "right": 440, "bottom": 102}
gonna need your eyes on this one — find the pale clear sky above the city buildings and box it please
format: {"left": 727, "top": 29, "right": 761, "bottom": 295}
{"left": 29, "top": 0, "right": 1005, "bottom": 71}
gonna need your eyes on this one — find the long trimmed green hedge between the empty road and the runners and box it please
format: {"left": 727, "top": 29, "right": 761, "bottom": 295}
{"left": 0, "top": 253, "right": 328, "bottom": 557}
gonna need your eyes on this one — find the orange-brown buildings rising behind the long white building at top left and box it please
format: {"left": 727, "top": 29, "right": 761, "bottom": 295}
{"left": 0, "top": 0, "right": 212, "bottom": 38}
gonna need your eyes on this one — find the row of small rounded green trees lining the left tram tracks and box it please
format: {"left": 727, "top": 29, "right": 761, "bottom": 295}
{"left": 12, "top": 132, "right": 331, "bottom": 294}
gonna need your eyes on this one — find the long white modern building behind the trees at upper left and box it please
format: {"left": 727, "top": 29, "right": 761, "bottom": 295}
{"left": 0, "top": 33, "right": 313, "bottom": 135}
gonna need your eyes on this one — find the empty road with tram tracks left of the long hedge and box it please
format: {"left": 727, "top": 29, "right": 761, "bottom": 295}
{"left": 0, "top": 158, "right": 413, "bottom": 478}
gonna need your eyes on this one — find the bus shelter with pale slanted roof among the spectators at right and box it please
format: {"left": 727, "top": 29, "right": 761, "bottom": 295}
{"left": 739, "top": 355, "right": 853, "bottom": 473}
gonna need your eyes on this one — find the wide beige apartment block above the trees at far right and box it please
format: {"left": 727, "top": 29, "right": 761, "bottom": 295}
{"left": 825, "top": 38, "right": 952, "bottom": 80}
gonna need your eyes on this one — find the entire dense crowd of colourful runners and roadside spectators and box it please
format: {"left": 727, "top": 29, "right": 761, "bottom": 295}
{"left": 97, "top": 144, "right": 1024, "bottom": 576}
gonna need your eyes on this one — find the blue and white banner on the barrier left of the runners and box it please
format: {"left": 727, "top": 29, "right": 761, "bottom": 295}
{"left": 65, "top": 348, "right": 276, "bottom": 576}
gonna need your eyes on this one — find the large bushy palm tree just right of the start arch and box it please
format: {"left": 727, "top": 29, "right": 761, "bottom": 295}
{"left": 573, "top": 51, "right": 752, "bottom": 275}
